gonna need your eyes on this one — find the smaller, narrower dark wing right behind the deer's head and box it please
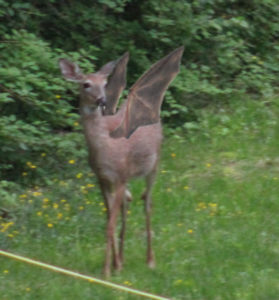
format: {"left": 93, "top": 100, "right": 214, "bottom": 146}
{"left": 104, "top": 52, "right": 129, "bottom": 115}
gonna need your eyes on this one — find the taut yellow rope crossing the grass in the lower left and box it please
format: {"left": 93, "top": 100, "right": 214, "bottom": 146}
{"left": 0, "top": 250, "right": 168, "bottom": 300}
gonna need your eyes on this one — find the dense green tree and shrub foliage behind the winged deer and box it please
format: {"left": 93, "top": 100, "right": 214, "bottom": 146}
{"left": 0, "top": 0, "right": 279, "bottom": 179}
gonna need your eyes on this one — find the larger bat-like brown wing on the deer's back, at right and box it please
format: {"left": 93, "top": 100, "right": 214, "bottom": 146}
{"left": 111, "top": 47, "right": 184, "bottom": 138}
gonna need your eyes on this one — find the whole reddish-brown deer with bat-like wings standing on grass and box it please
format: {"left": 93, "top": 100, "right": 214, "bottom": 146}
{"left": 59, "top": 46, "right": 184, "bottom": 277}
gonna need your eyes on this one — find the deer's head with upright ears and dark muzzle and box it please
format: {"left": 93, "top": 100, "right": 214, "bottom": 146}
{"left": 59, "top": 59, "right": 116, "bottom": 114}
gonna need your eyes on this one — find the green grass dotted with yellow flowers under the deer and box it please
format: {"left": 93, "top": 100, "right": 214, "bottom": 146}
{"left": 0, "top": 99, "right": 279, "bottom": 300}
